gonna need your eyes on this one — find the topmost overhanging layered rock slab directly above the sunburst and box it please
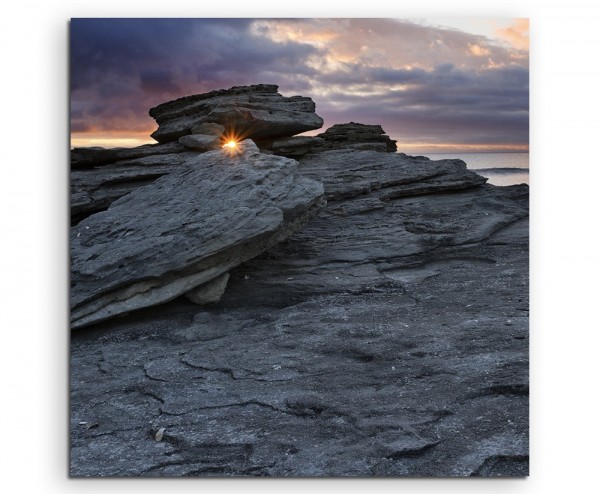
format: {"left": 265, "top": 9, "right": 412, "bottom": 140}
{"left": 150, "top": 84, "right": 323, "bottom": 143}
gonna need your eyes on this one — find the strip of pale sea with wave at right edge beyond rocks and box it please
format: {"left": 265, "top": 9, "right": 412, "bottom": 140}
{"left": 423, "top": 153, "right": 529, "bottom": 185}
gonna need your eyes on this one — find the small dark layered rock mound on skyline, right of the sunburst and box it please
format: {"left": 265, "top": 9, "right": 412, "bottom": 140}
{"left": 318, "top": 122, "right": 397, "bottom": 153}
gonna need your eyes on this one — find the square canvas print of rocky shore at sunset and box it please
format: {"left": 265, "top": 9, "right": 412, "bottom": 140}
{"left": 69, "top": 18, "right": 529, "bottom": 478}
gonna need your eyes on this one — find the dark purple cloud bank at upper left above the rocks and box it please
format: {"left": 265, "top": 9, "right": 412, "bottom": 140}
{"left": 71, "top": 19, "right": 318, "bottom": 133}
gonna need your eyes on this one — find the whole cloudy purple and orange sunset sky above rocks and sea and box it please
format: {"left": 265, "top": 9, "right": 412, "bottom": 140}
{"left": 70, "top": 18, "right": 529, "bottom": 154}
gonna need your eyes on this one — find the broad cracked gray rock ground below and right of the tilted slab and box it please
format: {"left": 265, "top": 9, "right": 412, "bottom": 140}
{"left": 70, "top": 145, "right": 529, "bottom": 477}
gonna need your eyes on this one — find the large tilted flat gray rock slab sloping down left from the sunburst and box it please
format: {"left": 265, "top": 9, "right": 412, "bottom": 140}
{"left": 71, "top": 141, "right": 324, "bottom": 328}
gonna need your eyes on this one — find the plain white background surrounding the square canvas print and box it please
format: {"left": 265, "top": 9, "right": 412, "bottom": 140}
{"left": 0, "top": 0, "right": 600, "bottom": 494}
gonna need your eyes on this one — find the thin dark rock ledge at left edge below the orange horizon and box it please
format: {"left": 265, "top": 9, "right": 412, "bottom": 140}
{"left": 71, "top": 142, "right": 186, "bottom": 170}
